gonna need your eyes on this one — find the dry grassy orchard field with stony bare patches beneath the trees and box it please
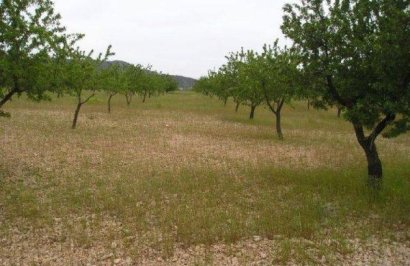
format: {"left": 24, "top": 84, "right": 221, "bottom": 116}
{"left": 0, "top": 93, "right": 410, "bottom": 265}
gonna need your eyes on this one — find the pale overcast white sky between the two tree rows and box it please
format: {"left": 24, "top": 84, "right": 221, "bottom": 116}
{"left": 54, "top": 0, "right": 296, "bottom": 78}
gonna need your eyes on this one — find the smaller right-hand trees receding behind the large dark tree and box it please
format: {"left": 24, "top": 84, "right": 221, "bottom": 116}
{"left": 195, "top": 41, "right": 302, "bottom": 139}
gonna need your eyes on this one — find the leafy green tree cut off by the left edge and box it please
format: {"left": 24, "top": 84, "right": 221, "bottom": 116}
{"left": 0, "top": 0, "right": 81, "bottom": 114}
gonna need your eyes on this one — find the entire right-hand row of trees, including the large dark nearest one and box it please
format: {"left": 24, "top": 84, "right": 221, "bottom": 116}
{"left": 197, "top": 0, "right": 410, "bottom": 188}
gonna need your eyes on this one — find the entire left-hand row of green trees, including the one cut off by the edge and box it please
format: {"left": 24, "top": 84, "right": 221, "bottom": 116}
{"left": 0, "top": 0, "right": 177, "bottom": 129}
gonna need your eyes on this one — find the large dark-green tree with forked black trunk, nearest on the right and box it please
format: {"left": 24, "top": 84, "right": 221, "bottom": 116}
{"left": 282, "top": 0, "right": 410, "bottom": 187}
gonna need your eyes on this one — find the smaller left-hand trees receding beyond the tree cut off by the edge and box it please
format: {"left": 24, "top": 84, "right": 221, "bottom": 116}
{"left": 67, "top": 57, "right": 178, "bottom": 129}
